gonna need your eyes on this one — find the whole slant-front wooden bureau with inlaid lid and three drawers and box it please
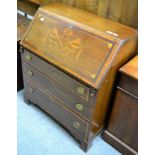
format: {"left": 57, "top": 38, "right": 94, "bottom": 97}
{"left": 21, "top": 3, "right": 137, "bottom": 151}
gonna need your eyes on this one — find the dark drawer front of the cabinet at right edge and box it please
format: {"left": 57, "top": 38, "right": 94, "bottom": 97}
{"left": 118, "top": 75, "right": 138, "bottom": 97}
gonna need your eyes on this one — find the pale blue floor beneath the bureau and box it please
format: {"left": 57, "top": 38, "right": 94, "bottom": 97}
{"left": 17, "top": 91, "right": 121, "bottom": 155}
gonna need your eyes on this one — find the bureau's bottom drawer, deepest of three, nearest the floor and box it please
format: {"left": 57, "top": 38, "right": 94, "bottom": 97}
{"left": 24, "top": 79, "right": 89, "bottom": 139}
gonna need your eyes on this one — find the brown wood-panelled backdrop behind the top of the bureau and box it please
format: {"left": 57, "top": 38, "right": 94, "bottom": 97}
{"left": 40, "top": 0, "right": 138, "bottom": 28}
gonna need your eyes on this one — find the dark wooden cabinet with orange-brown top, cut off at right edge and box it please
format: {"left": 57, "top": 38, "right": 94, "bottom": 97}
{"left": 103, "top": 56, "right": 138, "bottom": 155}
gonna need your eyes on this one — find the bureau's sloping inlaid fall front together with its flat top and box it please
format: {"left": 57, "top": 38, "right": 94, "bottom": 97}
{"left": 21, "top": 3, "right": 137, "bottom": 89}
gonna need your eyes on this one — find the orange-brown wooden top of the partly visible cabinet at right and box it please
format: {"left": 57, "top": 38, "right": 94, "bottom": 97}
{"left": 120, "top": 55, "right": 138, "bottom": 80}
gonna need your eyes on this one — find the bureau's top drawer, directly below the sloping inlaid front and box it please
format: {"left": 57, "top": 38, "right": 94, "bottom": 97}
{"left": 22, "top": 50, "right": 90, "bottom": 101}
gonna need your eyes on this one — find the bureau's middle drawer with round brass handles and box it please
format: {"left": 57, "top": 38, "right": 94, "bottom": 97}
{"left": 23, "top": 62, "right": 91, "bottom": 120}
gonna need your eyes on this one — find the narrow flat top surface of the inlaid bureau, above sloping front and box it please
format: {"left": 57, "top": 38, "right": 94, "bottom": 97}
{"left": 40, "top": 3, "right": 137, "bottom": 39}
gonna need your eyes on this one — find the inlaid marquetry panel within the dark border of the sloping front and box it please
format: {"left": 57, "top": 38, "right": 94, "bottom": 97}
{"left": 24, "top": 14, "right": 114, "bottom": 81}
